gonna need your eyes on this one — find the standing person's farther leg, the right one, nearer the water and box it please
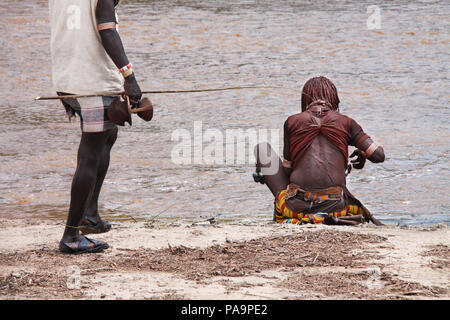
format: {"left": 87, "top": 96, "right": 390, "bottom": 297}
{"left": 83, "top": 128, "right": 118, "bottom": 225}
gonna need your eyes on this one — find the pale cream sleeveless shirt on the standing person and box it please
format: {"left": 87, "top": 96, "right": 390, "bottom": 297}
{"left": 49, "top": 0, "right": 123, "bottom": 94}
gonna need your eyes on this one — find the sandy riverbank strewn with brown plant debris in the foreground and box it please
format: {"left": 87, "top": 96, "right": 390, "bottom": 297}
{"left": 0, "top": 219, "right": 450, "bottom": 300}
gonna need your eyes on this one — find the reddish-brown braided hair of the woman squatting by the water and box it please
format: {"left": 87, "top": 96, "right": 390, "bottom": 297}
{"left": 302, "top": 76, "right": 340, "bottom": 111}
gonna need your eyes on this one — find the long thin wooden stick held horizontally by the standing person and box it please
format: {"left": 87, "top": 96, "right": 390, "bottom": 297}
{"left": 34, "top": 86, "right": 296, "bottom": 100}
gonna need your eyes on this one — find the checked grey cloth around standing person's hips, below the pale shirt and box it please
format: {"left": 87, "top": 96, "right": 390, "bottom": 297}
{"left": 58, "top": 92, "right": 117, "bottom": 132}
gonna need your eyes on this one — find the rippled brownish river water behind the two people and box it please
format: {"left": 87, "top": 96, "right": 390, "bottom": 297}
{"left": 0, "top": 0, "right": 450, "bottom": 224}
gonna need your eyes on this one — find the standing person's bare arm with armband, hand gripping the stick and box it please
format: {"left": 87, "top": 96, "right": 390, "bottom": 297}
{"left": 95, "top": 0, "right": 142, "bottom": 104}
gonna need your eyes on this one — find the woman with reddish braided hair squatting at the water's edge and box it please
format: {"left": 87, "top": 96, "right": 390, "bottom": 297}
{"left": 255, "top": 77, "right": 385, "bottom": 225}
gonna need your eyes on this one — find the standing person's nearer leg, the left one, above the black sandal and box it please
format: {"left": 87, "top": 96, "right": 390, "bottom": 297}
{"left": 61, "top": 130, "right": 112, "bottom": 248}
